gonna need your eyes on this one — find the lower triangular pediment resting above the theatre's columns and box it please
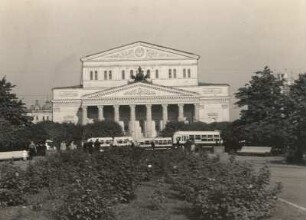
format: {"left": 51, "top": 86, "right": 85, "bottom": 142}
{"left": 83, "top": 82, "right": 199, "bottom": 99}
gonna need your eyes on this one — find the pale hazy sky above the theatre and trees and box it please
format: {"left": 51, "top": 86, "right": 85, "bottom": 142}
{"left": 0, "top": 0, "right": 306, "bottom": 119}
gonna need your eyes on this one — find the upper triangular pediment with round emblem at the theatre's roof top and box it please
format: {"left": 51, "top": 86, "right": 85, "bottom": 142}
{"left": 81, "top": 42, "right": 199, "bottom": 62}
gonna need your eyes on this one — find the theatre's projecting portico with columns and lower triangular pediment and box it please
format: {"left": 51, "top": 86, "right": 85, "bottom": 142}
{"left": 81, "top": 82, "right": 199, "bottom": 138}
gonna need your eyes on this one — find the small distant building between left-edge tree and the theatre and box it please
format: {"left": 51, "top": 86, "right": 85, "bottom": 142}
{"left": 27, "top": 100, "right": 52, "bottom": 124}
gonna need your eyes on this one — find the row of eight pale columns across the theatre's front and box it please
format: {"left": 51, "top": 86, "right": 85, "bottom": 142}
{"left": 82, "top": 103, "right": 199, "bottom": 125}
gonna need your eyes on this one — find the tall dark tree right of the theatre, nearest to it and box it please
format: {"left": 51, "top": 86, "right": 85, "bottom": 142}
{"left": 235, "top": 67, "right": 287, "bottom": 147}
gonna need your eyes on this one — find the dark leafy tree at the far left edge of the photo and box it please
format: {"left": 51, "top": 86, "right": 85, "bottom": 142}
{"left": 0, "top": 77, "right": 30, "bottom": 126}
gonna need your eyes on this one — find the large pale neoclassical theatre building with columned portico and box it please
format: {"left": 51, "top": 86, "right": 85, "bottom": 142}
{"left": 52, "top": 42, "right": 230, "bottom": 139}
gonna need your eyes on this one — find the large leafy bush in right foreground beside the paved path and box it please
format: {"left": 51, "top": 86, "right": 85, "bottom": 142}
{"left": 172, "top": 154, "right": 280, "bottom": 220}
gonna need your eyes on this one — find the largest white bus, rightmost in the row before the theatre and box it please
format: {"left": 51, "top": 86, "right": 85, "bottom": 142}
{"left": 173, "top": 131, "right": 223, "bottom": 147}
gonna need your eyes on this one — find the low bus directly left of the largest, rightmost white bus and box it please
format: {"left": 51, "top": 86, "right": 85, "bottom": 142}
{"left": 137, "top": 137, "right": 173, "bottom": 150}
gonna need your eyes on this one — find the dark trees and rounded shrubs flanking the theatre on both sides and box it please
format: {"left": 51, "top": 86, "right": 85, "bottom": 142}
{"left": 0, "top": 67, "right": 306, "bottom": 161}
